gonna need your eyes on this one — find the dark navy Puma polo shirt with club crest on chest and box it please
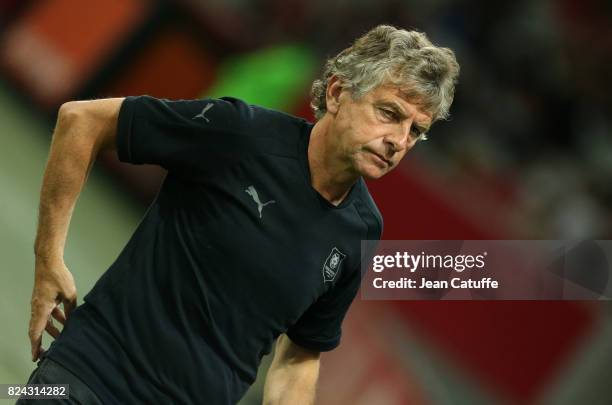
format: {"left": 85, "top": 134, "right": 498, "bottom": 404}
{"left": 49, "top": 96, "right": 382, "bottom": 404}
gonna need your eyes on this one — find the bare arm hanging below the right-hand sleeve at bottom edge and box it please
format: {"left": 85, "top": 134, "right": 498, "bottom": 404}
{"left": 263, "top": 335, "right": 321, "bottom": 405}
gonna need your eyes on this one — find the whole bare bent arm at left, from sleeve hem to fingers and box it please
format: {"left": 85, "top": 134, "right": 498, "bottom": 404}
{"left": 29, "top": 98, "right": 123, "bottom": 361}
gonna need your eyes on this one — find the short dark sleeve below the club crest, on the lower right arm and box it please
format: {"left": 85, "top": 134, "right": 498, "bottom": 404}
{"left": 286, "top": 269, "right": 361, "bottom": 352}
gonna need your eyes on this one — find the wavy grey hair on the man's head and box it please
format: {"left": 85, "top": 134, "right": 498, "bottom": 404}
{"left": 310, "top": 25, "right": 459, "bottom": 121}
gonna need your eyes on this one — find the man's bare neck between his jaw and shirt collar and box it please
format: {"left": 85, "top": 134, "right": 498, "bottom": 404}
{"left": 308, "top": 119, "right": 359, "bottom": 206}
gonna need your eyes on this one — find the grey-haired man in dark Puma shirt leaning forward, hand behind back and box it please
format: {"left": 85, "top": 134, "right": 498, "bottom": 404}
{"left": 29, "top": 26, "right": 459, "bottom": 404}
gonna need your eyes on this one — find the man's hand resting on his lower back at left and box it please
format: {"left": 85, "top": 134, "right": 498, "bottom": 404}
{"left": 29, "top": 258, "right": 77, "bottom": 361}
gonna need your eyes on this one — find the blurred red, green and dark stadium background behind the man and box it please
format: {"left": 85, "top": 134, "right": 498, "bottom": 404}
{"left": 0, "top": 0, "right": 612, "bottom": 405}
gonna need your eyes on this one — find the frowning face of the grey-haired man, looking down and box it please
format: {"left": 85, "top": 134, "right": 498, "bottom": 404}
{"left": 328, "top": 83, "right": 431, "bottom": 179}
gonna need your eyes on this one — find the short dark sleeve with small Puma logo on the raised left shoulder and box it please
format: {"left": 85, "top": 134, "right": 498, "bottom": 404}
{"left": 117, "top": 96, "right": 251, "bottom": 174}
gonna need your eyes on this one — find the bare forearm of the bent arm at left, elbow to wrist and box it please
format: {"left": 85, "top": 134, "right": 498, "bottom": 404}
{"left": 34, "top": 106, "right": 99, "bottom": 260}
